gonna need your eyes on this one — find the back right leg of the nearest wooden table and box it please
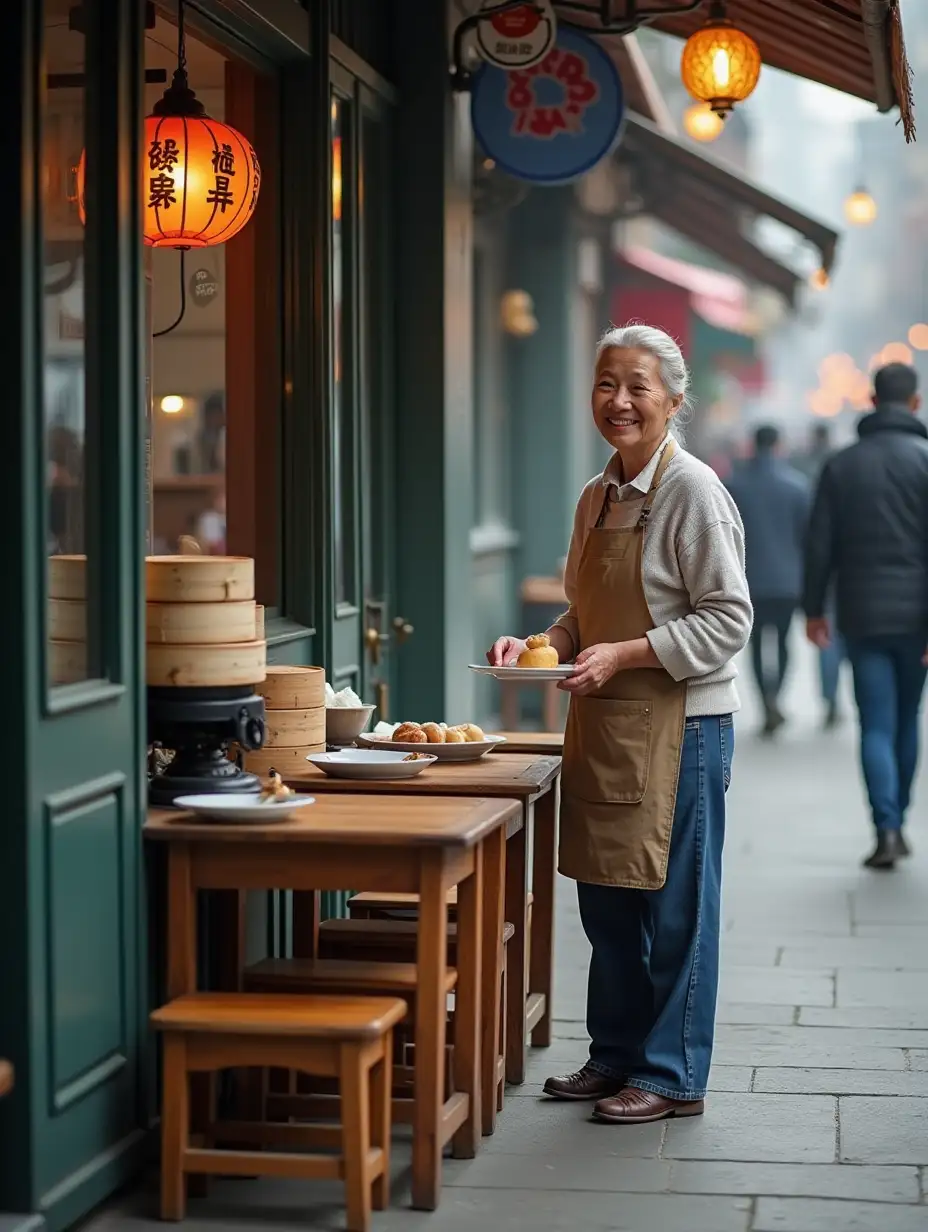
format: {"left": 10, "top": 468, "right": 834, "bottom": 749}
{"left": 451, "top": 844, "right": 483, "bottom": 1159}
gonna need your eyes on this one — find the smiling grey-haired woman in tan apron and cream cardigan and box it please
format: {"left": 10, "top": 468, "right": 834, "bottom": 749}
{"left": 487, "top": 325, "right": 752, "bottom": 1125}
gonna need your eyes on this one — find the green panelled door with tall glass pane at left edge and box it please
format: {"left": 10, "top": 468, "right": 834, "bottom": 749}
{"left": 0, "top": 0, "right": 150, "bottom": 1230}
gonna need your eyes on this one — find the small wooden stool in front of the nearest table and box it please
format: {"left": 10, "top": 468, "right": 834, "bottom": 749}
{"left": 152, "top": 993, "right": 405, "bottom": 1232}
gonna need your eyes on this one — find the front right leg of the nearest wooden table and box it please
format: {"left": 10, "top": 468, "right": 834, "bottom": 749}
{"left": 412, "top": 851, "right": 448, "bottom": 1211}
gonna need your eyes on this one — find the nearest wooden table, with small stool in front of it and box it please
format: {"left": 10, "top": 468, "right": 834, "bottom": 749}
{"left": 144, "top": 795, "right": 521, "bottom": 1210}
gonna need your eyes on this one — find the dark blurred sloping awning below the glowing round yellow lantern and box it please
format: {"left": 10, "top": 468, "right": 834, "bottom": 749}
{"left": 615, "top": 116, "right": 838, "bottom": 304}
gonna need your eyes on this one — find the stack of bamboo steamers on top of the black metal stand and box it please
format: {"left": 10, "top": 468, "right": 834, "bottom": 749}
{"left": 145, "top": 556, "right": 267, "bottom": 689}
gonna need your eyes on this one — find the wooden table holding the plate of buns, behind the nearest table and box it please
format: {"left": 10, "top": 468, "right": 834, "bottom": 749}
{"left": 286, "top": 745, "right": 561, "bottom": 1084}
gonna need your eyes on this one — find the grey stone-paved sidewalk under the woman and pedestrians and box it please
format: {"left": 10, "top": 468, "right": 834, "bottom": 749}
{"left": 90, "top": 642, "right": 928, "bottom": 1232}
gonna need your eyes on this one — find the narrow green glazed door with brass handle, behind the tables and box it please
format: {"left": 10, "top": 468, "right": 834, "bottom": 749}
{"left": 328, "top": 63, "right": 401, "bottom": 718}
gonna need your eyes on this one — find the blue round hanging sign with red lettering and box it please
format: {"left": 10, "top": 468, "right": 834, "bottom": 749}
{"left": 471, "top": 26, "right": 625, "bottom": 184}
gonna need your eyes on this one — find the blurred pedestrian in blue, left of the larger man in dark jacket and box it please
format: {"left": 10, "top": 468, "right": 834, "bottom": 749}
{"left": 728, "top": 425, "right": 811, "bottom": 736}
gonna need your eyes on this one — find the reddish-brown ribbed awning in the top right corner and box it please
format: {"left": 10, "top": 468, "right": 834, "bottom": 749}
{"left": 556, "top": 0, "right": 914, "bottom": 140}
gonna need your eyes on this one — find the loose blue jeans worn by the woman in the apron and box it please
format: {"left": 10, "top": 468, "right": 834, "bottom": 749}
{"left": 577, "top": 715, "right": 735, "bottom": 1099}
